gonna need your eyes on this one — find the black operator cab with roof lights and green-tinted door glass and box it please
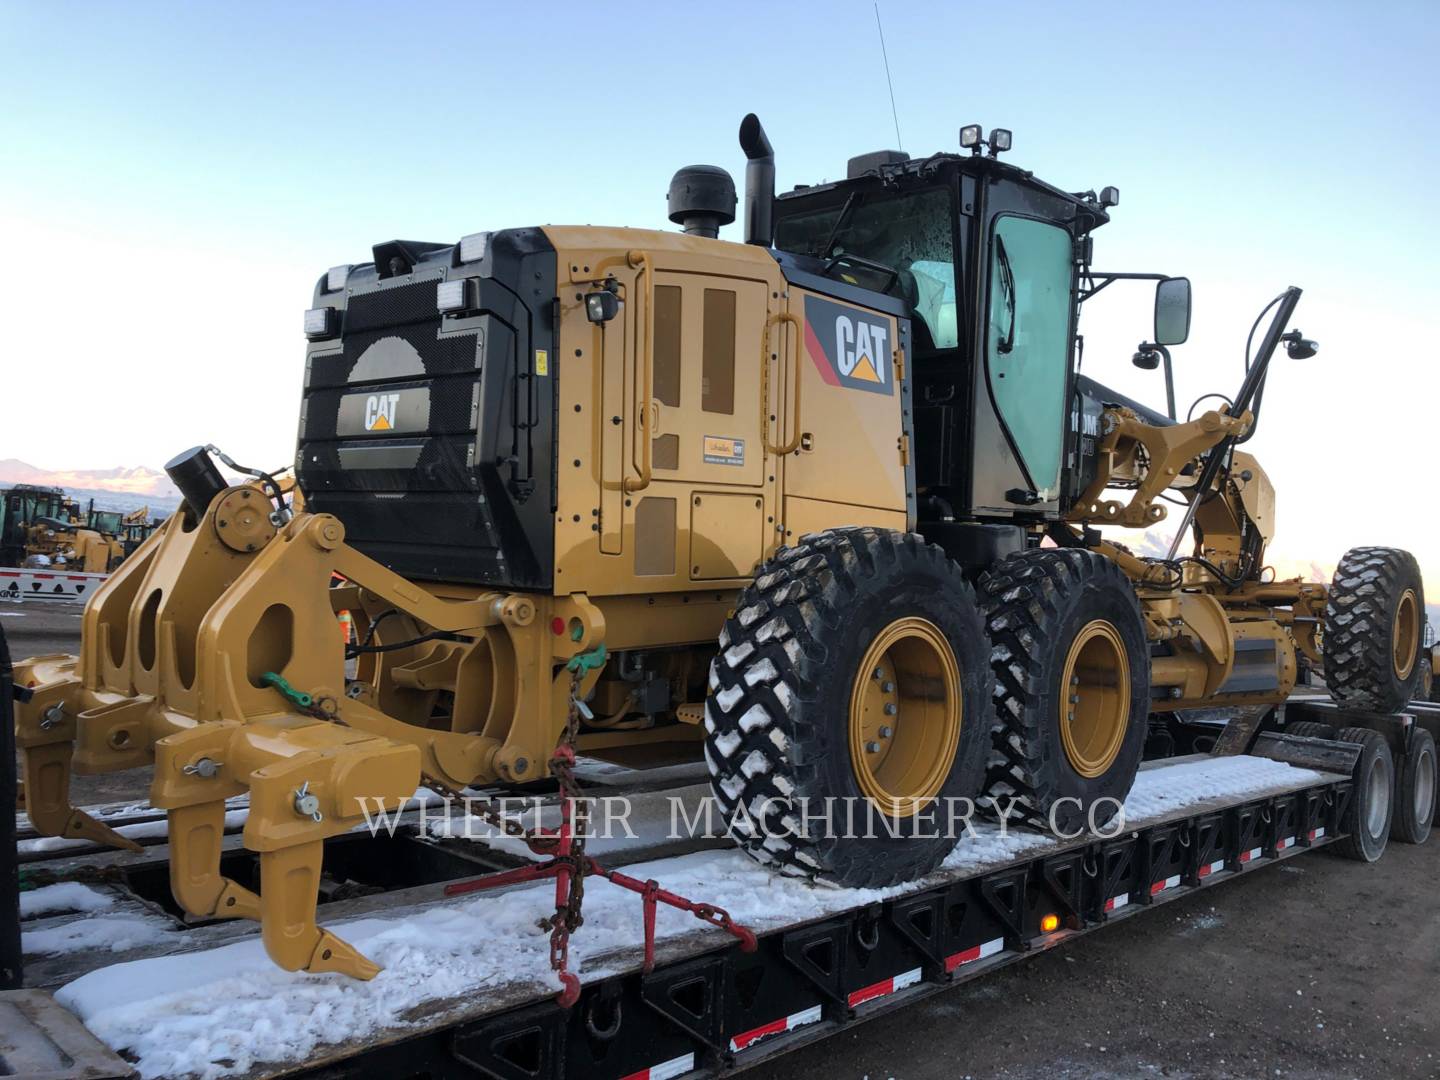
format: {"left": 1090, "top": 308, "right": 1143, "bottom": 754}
{"left": 775, "top": 127, "right": 1189, "bottom": 562}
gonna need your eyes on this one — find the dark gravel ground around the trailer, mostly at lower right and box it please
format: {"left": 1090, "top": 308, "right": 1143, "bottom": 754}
{"left": 11, "top": 603, "right": 1440, "bottom": 1080}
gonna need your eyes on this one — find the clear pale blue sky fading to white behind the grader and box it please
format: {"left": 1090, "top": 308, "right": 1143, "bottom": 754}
{"left": 0, "top": 0, "right": 1440, "bottom": 595}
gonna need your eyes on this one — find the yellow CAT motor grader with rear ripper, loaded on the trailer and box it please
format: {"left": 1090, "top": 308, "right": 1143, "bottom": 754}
{"left": 16, "top": 115, "right": 1423, "bottom": 978}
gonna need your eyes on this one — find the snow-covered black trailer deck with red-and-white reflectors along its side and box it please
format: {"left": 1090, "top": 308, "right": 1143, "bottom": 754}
{"left": 11, "top": 736, "right": 1351, "bottom": 1079}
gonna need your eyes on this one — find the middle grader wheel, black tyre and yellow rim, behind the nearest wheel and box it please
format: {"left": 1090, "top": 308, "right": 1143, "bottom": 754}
{"left": 981, "top": 549, "right": 1151, "bottom": 832}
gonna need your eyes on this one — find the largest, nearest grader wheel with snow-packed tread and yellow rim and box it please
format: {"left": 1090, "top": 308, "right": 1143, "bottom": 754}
{"left": 706, "top": 528, "right": 992, "bottom": 887}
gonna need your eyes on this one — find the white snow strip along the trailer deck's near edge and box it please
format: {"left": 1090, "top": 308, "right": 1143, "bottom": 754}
{"left": 56, "top": 757, "right": 1326, "bottom": 1077}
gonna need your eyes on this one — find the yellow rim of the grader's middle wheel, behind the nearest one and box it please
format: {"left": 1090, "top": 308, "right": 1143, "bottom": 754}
{"left": 1060, "top": 619, "right": 1130, "bottom": 778}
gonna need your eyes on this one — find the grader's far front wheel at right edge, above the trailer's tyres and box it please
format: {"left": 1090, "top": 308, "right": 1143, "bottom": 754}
{"left": 1323, "top": 547, "right": 1426, "bottom": 713}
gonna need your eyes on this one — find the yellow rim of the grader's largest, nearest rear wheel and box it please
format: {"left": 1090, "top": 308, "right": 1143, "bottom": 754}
{"left": 850, "top": 618, "right": 962, "bottom": 818}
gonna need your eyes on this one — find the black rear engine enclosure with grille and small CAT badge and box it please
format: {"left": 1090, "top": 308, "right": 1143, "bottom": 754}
{"left": 295, "top": 229, "right": 559, "bottom": 589}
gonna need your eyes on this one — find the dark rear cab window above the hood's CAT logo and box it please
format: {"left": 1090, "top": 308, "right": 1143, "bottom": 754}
{"left": 775, "top": 187, "right": 959, "bottom": 348}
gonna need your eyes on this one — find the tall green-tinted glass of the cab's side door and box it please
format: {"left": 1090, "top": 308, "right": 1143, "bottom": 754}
{"left": 986, "top": 216, "right": 1074, "bottom": 498}
